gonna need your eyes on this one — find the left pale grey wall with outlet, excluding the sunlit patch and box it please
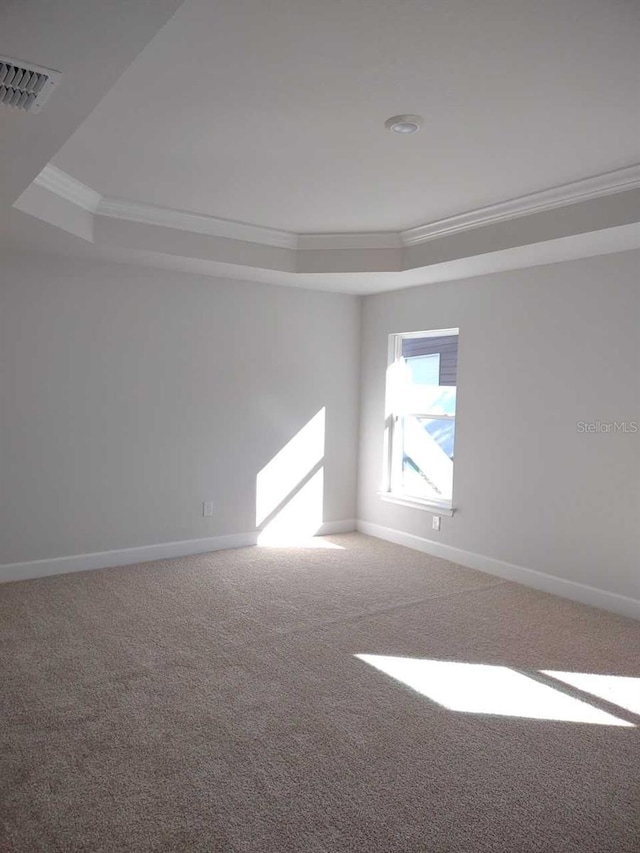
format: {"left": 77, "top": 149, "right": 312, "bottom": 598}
{"left": 0, "top": 254, "right": 360, "bottom": 564}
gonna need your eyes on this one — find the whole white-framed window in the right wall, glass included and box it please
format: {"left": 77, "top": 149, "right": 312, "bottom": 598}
{"left": 382, "top": 329, "right": 458, "bottom": 512}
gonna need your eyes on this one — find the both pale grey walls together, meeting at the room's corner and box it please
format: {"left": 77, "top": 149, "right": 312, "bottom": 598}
{"left": 0, "top": 245, "right": 640, "bottom": 599}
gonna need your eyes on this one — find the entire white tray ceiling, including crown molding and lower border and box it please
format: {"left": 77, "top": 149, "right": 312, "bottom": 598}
{"left": 5, "top": 0, "right": 640, "bottom": 294}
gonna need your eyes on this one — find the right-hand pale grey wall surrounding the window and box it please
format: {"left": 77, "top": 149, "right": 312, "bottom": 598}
{"left": 359, "top": 252, "right": 640, "bottom": 599}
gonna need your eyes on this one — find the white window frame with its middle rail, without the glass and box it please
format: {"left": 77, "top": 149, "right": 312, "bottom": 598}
{"left": 378, "top": 329, "right": 460, "bottom": 515}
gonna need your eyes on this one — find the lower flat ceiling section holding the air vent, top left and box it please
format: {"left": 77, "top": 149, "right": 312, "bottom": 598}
{"left": 0, "top": 0, "right": 180, "bottom": 213}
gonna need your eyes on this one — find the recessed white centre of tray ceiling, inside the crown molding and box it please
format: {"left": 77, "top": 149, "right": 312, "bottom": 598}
{"left": 53, "top": 0, "right": 640, "bottom": 233}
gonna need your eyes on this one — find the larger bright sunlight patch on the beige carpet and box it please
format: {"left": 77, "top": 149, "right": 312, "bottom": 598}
{"left": 355, "top": 654, "right": 634, "bottom": 728}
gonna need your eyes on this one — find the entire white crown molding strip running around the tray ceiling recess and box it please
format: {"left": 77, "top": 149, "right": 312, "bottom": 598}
{"left": 34, "top": 164, "right": 640, "bottom": 251}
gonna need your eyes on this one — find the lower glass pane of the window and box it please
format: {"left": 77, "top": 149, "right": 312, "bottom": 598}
{"left": 400, "top": 415, "right": 455, "bottom": 501}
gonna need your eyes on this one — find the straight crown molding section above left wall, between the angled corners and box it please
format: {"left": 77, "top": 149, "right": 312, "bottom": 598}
{"left": 95, "top": 196, "right": 298, "bottom": 249}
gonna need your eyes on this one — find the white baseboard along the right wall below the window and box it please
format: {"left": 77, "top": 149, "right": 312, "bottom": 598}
{"left": 356, "top": 520, "right": 640, "bottom": 619}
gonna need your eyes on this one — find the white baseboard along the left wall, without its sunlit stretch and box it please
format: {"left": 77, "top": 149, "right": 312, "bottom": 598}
{"left": 0, "top": 519, "right": 356, "bottom": 583}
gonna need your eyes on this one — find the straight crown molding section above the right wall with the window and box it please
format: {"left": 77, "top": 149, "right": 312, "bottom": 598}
{"left": 400, "top": 163, "right": 640, "bottom": 246}
